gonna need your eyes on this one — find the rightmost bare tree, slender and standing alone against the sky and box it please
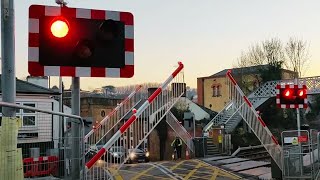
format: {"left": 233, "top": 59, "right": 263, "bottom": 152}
{"left": 285, "top": 38, "right": 310, "bottom": 78}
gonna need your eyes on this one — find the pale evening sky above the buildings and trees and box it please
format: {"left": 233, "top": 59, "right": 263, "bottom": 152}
{"left": 4, "top": 0, "right": 320, "bottom": 89}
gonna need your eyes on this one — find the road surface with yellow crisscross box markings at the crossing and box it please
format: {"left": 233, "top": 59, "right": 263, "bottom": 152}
{"left": 110, "top": 159, "right": 241, "bottom": 180}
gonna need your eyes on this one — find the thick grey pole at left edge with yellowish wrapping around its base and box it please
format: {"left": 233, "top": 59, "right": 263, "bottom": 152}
{"left": 0, "top": 0, "right": 23, "bottom": 180}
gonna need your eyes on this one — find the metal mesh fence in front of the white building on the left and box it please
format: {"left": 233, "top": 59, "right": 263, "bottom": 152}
{"left": 0, "top": 102, "right": 85, "bottom": 180}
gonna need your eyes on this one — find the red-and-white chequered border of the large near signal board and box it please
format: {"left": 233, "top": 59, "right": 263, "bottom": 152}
{"left": 28, "top": 5, "right": 134, "bottom": 78}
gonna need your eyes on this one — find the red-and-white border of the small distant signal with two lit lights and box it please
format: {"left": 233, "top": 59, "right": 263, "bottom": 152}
{"left": 276, "top": 84, "right": 308, "bottom": 108}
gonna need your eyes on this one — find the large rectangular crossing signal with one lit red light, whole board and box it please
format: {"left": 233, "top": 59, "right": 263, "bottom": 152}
{"left": 28, "top": 5, "right": 134, "bottom": 78}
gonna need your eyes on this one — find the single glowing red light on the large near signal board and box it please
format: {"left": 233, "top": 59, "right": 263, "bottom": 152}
{"left": 50, "top": 19, "right": 69, "bottom": 38}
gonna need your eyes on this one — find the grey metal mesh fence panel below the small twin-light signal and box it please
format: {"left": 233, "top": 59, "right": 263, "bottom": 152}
{"left": 281, "top": 130, "right": 319, "bottom": 179}
